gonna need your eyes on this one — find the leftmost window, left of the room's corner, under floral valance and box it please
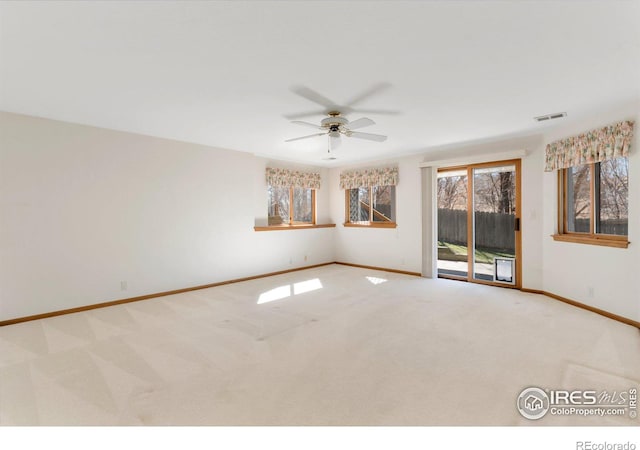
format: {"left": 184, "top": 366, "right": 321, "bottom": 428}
{"left": 268, "top": 186, "right": 316, "bottom": 226}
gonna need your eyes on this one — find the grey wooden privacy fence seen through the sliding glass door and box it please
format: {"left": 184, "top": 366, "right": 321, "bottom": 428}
{"left": 438, "top": 209, "right": 515, "bottom": 250}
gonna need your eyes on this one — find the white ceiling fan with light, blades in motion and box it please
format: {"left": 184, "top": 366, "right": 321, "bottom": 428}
{"left": 285, "top": 111, "right": 387, "bottom": 149}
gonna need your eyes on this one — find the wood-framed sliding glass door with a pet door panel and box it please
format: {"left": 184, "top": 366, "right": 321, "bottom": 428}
{"left": 437, "top": 160, "right": 520, "bottom": 286}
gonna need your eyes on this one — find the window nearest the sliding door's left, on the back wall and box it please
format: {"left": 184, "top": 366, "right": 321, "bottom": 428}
{"left": 345, "top": 186, "right": 396, "bottom": 228}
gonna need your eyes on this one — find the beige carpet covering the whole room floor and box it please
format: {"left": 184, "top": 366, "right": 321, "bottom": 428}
{"left": 0, "top": 265, "right": 640, "bottom": 425}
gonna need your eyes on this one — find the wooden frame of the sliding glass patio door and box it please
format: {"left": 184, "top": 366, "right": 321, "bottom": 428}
{"left": 435, "top": 159, "right": 522, "bottom": 289}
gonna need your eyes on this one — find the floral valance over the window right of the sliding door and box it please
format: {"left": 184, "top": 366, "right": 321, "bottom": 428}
{"left": 544, "top": 120, "right": 633, "bottom": 172}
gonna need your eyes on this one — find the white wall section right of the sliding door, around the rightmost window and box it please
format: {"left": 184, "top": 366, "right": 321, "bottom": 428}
{"left": 542, "top": 102, "right": 640, "bottom": 321}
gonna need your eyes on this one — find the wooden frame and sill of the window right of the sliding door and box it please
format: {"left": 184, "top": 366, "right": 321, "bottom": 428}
{"left": 552, "top": 163, "right": 630, "bottom": 248}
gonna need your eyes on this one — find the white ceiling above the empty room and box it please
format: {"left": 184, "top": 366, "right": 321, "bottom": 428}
{"left": 0, "top": 0, "right": 640, "bottom": 165}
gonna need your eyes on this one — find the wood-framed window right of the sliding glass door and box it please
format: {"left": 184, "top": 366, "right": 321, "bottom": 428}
{"left": 554, "top": 157, "right": 629, "bottom": 247}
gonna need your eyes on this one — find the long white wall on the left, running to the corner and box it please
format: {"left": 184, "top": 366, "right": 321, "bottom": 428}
{"left": 0, "top": 113, "right": 335, "bottom": 320}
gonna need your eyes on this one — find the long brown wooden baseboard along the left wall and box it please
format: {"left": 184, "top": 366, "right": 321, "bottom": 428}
{"left": 0, "top": 262, "right": 333, "bottom": 327}
